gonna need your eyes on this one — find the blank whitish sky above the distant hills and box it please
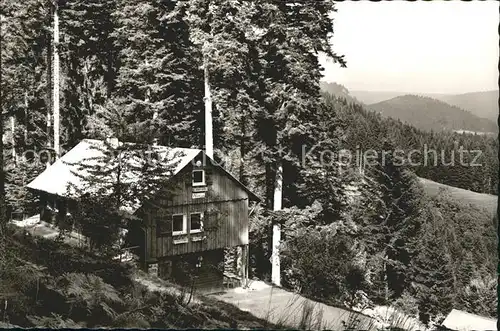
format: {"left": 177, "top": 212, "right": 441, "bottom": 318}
{"left": 321, "top": 1, "right": 499, "bottom": 93}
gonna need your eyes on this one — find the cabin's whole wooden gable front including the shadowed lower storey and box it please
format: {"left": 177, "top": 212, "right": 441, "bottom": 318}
{"left": 130, "top": 153, "right": 254, "bottom": 291}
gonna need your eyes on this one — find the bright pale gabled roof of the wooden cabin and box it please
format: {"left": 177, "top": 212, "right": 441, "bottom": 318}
{"left": 27, "top": 139, "right": 260, "bottom": 209}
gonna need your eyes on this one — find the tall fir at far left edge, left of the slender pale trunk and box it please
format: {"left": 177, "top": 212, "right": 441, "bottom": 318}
{"left": 1, "top": 1, "right": 51, "bottom": 226}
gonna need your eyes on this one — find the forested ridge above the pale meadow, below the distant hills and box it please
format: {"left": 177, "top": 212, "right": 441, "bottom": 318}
{"left": 324, "top": 83, "right": 498, "bottom": 195}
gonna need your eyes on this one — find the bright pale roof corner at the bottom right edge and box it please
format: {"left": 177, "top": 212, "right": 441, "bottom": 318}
{"left": 441, "top": 309, "right": 497, "bottom": 331}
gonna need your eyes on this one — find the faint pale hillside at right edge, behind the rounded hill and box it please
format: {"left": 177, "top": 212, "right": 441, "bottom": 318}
{"left": 429, "top": 90, "right": 499, "bottom": 122}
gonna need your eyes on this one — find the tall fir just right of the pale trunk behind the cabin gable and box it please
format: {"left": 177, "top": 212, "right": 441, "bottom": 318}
{"left": 179, "top": 0, "right": 262, "bottom": 174}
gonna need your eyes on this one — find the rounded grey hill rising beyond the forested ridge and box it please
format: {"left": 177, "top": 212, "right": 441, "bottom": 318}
{"left": 368, "top": 95, "right": 498, "bottom": 132}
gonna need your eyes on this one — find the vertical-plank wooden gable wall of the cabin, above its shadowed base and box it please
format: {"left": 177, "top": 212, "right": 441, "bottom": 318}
{"left": 140, "top": 155, "right": 249, "bottom": 263}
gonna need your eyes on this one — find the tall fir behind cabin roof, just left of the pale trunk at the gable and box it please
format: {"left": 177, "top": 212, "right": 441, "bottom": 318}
{"left": 114, "top": 0, "right": 203, "bottom": 147}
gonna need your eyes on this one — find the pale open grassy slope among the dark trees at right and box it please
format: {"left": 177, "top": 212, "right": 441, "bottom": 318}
{"left": 420, "top": 178, "right": 498, "bottom": 215}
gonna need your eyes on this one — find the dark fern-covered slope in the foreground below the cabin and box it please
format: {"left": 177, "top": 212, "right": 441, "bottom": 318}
{"left": 0, "top": 224, "right": 278, "bottom": 329}
